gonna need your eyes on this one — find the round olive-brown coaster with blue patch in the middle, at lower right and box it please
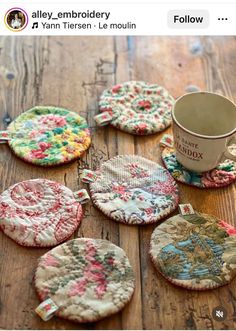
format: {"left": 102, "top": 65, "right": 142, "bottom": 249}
{"left": 150, "top": 213, "right": 236, "bottom": 290}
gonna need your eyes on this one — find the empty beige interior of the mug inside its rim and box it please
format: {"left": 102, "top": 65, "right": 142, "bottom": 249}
{"left": 173, "top": 92, "right": 236, "bottom": 137}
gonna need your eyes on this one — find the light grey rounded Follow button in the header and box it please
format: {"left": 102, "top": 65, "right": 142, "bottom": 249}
{"left": 167, "top": 10, "right": 209, "bottom": 29}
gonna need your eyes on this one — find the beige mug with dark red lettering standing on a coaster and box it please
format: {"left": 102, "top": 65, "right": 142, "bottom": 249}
{"left": 172, "top": 92, "right": 236, "bottom": 172}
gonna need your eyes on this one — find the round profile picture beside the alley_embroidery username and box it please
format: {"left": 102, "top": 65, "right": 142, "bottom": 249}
{"left": 5, "top": 8, "right": 28, "bottom": 32}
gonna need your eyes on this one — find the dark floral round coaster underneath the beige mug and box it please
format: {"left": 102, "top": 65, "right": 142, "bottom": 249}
{"left": 162, "top": 147, "right": 236, "bottom": 188}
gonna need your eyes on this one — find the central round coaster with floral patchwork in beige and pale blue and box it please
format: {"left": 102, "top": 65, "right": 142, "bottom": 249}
{"left": 82, "top": 155, "right": 178, "bottom": 224}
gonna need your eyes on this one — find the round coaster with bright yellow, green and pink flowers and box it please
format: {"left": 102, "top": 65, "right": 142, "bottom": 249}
{"left": 0, "top": 106, "right": 91, "bottom": 166}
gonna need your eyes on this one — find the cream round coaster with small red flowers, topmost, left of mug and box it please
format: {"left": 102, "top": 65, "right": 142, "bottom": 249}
{"left": 95, "top": 81, "right": 174, "bottom": 135}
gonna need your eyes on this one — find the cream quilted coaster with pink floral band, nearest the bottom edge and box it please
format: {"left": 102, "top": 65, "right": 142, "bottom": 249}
{"left": 35, "top": 238, "right": 135, "bottom": 323}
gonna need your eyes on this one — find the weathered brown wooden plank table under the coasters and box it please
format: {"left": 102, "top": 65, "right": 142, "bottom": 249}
{"left": 0, "top": 36, "right": 236, "bottom": 329}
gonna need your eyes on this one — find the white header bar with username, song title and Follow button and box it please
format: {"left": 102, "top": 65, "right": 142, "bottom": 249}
{"left": 0, "top": 2, "right": 236, "bottom": 35}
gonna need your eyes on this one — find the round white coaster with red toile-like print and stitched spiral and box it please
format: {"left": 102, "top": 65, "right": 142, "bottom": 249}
{"left": 0, "top": 179, "right": 88, "bottom": 247}
